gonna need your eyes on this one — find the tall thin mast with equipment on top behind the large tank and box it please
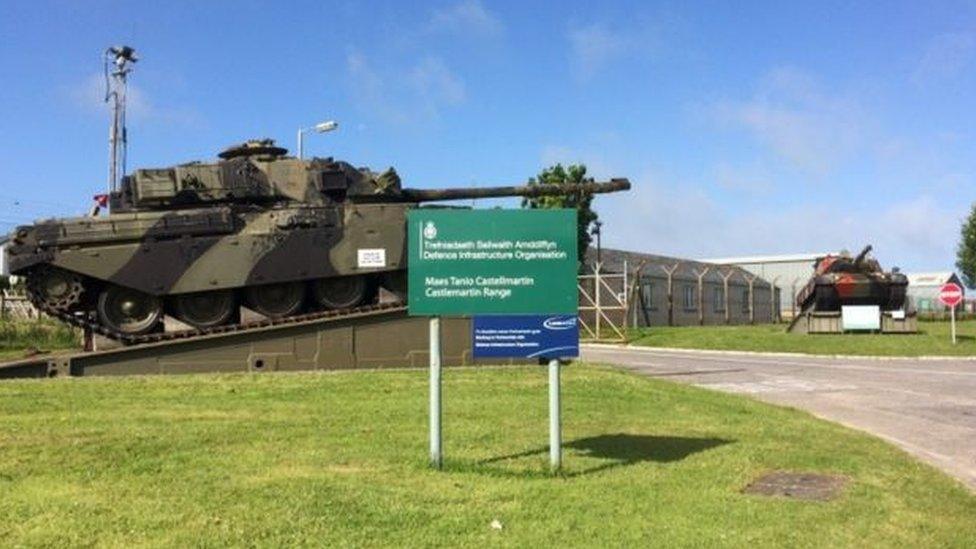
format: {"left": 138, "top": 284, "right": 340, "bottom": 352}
{"left": 104, "top": 46, "right": 139, "bottom": 194}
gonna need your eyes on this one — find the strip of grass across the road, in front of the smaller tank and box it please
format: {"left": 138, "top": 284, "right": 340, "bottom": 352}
{"left": 631, "top": 320, "right": 976, "bottom": 356}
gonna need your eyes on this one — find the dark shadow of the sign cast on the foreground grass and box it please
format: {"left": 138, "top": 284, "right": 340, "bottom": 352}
{"left": 464, "top": 433, "right": 735, "bottom": 477}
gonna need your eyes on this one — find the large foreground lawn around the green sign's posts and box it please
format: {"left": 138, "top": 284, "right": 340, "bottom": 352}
{"left": 0, "top": 365, "right": 976, "bottom": 547}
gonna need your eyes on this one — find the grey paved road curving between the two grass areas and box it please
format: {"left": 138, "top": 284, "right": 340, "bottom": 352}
{"left": 582, "top": 346, "right": 976, "bottom": 490}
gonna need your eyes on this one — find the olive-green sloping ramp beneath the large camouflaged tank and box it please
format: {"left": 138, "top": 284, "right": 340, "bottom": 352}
{"left": 0, "top": 303, "right": 488, "bottom": 379}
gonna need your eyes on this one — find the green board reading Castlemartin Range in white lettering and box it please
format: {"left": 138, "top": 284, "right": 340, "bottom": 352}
{"left": 407, "top": 208, "right": 579, "bottom": 315}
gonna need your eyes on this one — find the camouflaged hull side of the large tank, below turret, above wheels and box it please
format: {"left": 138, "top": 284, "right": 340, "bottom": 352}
{"left": 9, "top": 204, "right": 411, "bottom": 296}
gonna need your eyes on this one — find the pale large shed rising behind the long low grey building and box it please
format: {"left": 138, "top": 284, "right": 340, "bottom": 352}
{"left": 702, "top": 252, "right": 837, "bottom": 318}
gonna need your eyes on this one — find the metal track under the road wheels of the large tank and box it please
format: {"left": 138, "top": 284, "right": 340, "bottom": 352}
{"left": 34, "top": 301, "right": 405, "bottom": 345}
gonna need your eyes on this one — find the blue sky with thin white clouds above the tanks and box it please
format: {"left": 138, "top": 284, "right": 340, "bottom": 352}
{"left": 0, "top": 0, "right": 976, "bottom": 270}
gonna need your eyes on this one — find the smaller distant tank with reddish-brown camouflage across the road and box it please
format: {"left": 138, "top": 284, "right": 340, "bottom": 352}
{"left": 796, "top": 246, "right": 908, "bottom": 311}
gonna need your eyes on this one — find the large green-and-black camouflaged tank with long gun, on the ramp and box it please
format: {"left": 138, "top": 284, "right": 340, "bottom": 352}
{"left": 7, "top": 139, "right": 630, "bottom": 337}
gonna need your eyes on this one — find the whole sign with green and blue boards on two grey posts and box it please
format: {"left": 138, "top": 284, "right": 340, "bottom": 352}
{"left": 407, "top": 208, "right": 579, "bottom": 472}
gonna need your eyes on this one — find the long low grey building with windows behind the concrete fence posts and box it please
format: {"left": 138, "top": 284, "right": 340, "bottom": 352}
{"left": 580, "top": 248, "right": 781, "bottom": 326}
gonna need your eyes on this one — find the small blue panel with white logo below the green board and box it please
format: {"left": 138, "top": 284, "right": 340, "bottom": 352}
{"left": 471, "top": 315, "right": 579, "bottom": 358}
